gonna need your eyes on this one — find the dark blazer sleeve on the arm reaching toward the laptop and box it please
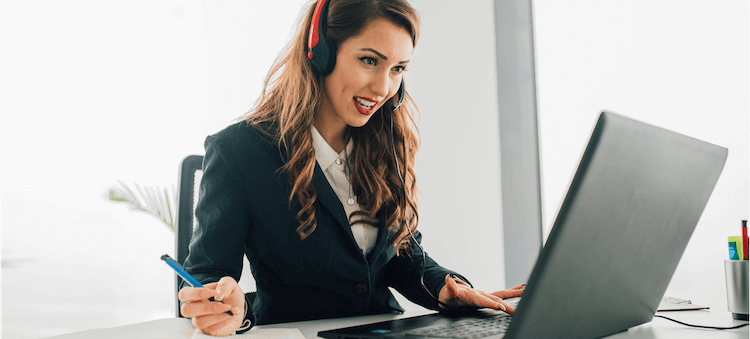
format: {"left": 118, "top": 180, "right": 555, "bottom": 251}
{"left": 384, "top": 231, "right": 471, "bottom": 310}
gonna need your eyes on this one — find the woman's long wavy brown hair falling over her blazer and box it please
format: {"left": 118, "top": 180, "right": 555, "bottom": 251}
{"left": 243, "top": 0, "right": 419, "bottom": 255}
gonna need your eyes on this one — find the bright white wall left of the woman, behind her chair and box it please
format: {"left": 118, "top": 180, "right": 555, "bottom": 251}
{"left": 0, "top": 0, "right": 301, "bottom": 338}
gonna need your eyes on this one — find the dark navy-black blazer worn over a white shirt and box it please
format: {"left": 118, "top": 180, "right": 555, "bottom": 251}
{"left": 185, "top": 122, "right": 468, "bottom": 324}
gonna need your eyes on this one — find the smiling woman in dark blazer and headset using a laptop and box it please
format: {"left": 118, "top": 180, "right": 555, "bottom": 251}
{"left": 179, "top": 0, "right": 523, "bottom": 335}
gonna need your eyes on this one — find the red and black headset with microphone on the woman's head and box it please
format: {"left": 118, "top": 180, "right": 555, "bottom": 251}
{"left": 307, "top": 0, "right": 406, "bottom": 110}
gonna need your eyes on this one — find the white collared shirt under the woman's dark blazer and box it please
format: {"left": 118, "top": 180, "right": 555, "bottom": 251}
{"left": 312, "top": 126, "right": 378, "bottom": 256}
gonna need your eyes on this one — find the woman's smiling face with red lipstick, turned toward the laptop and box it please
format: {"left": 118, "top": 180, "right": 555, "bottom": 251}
{"left": 316, "top": 18, "right": 414, "bottom": 130}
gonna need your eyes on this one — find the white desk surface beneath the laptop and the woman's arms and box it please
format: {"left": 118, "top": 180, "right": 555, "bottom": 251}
{"left": 45, "top": 310, "right": 750, "bottom": 339}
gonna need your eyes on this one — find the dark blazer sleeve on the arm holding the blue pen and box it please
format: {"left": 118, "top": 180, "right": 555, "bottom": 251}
{"left": 181, "top": 136, "right": 255, "bottom": 324}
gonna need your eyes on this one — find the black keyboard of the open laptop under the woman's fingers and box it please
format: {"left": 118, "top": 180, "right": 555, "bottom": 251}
{"left": 404, "top": 315, "right": 510, "bottom": 339}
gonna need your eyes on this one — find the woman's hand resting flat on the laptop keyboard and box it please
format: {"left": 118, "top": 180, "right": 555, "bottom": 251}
{"left": 438, "top": 275, "right": 526, "bottom": 315}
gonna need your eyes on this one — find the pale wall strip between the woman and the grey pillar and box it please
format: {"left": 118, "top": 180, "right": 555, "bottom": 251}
{"left": 407, "top": 0, "right": 505, "bottom": 310}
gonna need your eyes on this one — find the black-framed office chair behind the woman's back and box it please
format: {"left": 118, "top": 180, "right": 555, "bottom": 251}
{"left": 175, "top": 155, "right": 255, "bottom": 318}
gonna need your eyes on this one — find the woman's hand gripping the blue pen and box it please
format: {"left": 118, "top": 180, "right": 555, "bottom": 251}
{"left": 178, "top": 276, "right": 245, "bottom": 336}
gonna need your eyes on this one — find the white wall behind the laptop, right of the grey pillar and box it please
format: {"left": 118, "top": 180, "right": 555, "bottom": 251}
{"left": 533, "top": 0, "right": 750, "bottom": 310}
